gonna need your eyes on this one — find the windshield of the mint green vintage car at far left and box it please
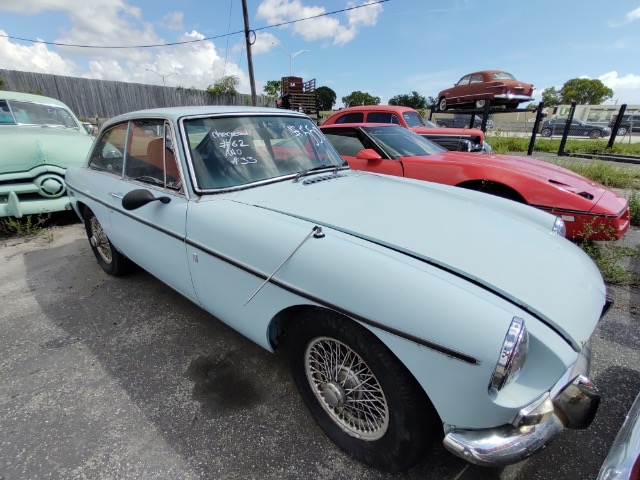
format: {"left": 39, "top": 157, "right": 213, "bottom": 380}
{"left": 0, "top": 100, "right": 80, "bottom": 129}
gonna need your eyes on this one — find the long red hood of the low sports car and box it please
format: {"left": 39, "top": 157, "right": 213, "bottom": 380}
{"left": 438, "top": 152, "right": 607, "bottom": 206}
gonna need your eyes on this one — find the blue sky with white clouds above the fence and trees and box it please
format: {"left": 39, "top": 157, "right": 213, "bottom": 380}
{"left": 0, "top": 0, "right": 640, "bottom": 107}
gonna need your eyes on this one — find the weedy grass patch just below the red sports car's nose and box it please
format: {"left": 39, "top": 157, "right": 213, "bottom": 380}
{"left": 578, "top": 242, "right": 640, "bottom": 285}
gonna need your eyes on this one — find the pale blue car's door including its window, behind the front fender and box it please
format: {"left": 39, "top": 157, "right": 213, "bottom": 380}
{"left": 109, "top": 119, "right": 197, "bottom": 302}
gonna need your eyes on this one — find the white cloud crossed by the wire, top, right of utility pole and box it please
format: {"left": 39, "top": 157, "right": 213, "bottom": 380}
{"left": 256, "top": 0, "right": 382, "bottom": 45}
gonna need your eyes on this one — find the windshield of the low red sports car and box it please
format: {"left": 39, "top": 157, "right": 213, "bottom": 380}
{"left": 363, "top": 126, "right": 446, "bottom": 159}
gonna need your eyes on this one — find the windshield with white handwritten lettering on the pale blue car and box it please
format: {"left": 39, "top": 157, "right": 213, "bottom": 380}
{"left": 182, "top": 115, "right": 347, "bottom": 190}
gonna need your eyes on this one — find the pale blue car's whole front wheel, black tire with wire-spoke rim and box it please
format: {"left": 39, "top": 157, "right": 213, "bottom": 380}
{"left": 287, "top": 312, "right": 442, "bottom": 471}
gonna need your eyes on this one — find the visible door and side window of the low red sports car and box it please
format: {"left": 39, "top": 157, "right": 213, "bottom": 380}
{"left": 322, "top": 128, "right": 404, "bottom": 177}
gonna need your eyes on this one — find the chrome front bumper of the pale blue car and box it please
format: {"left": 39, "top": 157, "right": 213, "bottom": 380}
{"left": 443, "top": 344, "right": 600, "bottom": 467}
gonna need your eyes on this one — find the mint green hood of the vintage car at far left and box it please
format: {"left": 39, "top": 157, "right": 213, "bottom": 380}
{"left": 0, "top": 125, "right": 93, "bottom": 173}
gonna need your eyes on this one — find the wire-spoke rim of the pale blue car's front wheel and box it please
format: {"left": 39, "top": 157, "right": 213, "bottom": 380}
{"left": 304, "top": 337, "right": 389, "bottom": 441}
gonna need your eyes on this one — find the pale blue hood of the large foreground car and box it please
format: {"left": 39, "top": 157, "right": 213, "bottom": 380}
{"left": 231, "top": 171, "right": 606, "bottom": 350}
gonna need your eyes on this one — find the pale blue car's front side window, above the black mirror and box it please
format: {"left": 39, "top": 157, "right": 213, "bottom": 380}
{"left": 124, "top": 119, "right": 180, "bottom": 190}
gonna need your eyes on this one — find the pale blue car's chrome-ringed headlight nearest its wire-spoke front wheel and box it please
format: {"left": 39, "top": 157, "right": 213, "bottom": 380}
{"left": 489, "top": 317, "right": 529, "bottom": 392}
